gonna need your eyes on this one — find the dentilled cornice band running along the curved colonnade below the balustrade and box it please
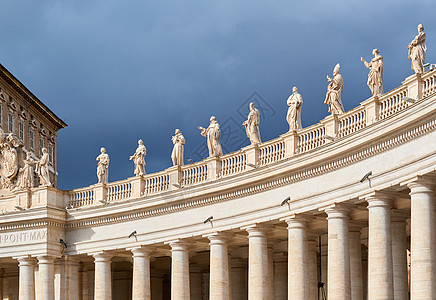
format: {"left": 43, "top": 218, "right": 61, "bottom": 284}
{"left": 67, "top": 105, "right": 436, "bottom": 229}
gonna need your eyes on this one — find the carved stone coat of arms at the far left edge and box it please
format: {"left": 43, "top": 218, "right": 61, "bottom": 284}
{"left": 0, "top": 129, "right": 23, "bottom": 190}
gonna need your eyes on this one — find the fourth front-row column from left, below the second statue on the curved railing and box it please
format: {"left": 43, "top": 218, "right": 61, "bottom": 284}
{"left": 130, "top": 247, "right": 151, "bottom": 300}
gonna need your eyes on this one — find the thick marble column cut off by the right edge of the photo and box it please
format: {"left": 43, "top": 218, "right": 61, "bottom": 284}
{"left": 408, "top": 178, "right": 436, "bottom": 300}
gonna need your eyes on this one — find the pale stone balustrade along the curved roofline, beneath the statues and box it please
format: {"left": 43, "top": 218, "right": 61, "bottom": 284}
{"left": 62, "top": 70, "right": 436, "bottom": 208}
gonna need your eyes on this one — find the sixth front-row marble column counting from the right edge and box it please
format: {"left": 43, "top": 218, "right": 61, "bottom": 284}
{"left": 207, "top": 233, "right": 230, "bottom": 300}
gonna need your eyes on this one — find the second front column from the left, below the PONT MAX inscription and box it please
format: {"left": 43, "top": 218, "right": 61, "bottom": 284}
{"left": 38, "top": 255, "right": 56, "bottom": 300}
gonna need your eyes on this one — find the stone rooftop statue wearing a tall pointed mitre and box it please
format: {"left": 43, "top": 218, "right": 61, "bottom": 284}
{"left": 324, "top": 64, "right": 344, "bottom": 115}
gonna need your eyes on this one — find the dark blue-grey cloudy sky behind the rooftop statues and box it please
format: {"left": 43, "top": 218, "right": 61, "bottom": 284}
{"left": 0, "top": 0, "right": 436, "bottom": 189}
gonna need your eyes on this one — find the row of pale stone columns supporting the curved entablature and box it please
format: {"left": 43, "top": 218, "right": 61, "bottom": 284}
{"left": 0, "top": 178, "right": 436, "bottom": 300}
